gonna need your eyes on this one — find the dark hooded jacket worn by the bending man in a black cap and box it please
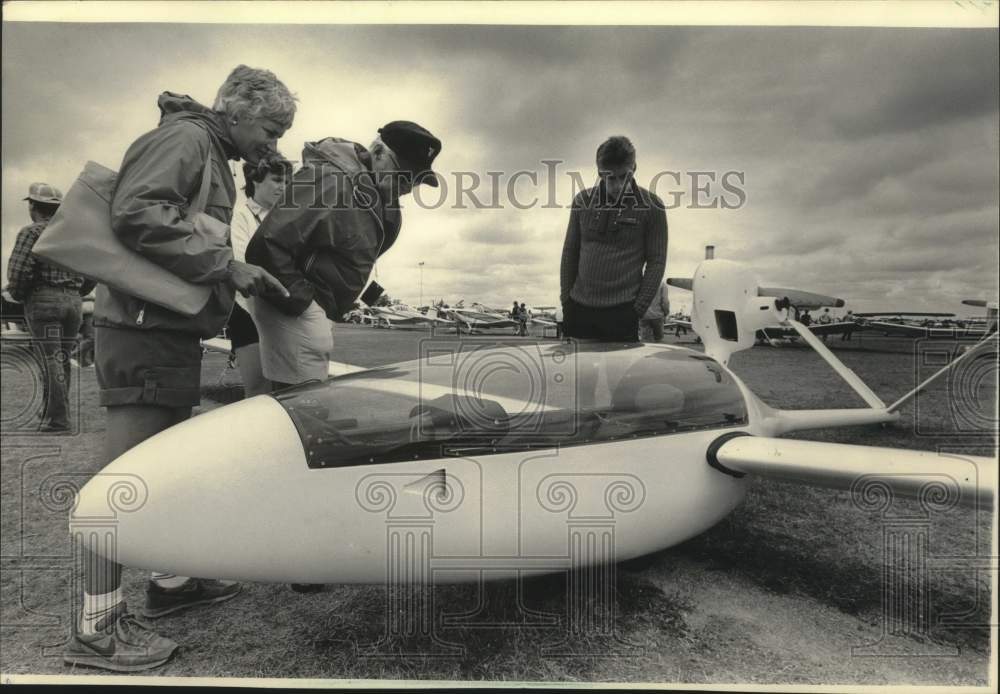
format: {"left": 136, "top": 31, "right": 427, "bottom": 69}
{"left": 246, "top": 137, "right": 402, "bottom": 321}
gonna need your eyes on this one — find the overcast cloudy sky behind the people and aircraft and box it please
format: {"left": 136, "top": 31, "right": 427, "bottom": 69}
{"left": 2, "top": 9, "right": 1000, "bottom": 313}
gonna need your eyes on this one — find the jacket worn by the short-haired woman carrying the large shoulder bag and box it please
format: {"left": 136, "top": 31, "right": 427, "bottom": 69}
{"left": 94, "top": 92, "right": 238, "bottom": 337}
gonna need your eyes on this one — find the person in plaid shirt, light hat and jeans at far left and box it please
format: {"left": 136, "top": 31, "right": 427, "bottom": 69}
{"left": 7, "top": 183, "right": 94, "bottom": 434}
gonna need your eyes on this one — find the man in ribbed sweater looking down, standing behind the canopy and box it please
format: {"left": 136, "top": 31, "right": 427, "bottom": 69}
{"left": 559, "top": 136, "right": 667, "bottom": 342}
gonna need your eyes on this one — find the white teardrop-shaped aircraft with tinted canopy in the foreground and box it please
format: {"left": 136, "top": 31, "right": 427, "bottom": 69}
{"left": 71, "top": 260, "right": 997, "bottom": 583}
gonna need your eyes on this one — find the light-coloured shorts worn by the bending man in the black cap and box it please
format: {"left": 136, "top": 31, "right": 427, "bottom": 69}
{"left": 250, "top": 298, "right": 333, "bottom": 383}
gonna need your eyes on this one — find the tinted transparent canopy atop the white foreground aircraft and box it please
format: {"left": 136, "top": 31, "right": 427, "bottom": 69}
{"left": 275, "top": 342, "right": 747, "bottom": 468}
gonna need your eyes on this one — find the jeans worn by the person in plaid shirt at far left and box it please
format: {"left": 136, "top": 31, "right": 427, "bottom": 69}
{"left": 24, "top": 287, "right": 82, "bottom": 428}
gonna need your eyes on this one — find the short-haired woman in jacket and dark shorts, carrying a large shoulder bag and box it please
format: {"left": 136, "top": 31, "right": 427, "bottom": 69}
{"left": 63, "top": 65, "right": 295, "bottom": 672}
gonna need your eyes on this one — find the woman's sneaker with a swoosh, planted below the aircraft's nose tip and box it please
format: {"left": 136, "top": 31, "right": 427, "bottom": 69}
{"left": 63, "top": 602, "right": 177, "bottom": 672}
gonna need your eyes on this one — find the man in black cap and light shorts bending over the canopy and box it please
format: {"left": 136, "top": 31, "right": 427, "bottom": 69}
{"left": 247, "top": 121, "right": 441, "bottom": 388}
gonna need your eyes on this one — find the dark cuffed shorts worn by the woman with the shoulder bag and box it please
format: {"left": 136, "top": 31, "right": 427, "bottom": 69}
{"left": 94, "top": 325, "right": 201, "bottom": 407}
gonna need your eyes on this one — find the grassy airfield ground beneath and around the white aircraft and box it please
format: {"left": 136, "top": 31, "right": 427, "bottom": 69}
{"left": 0, "top": 326, "right": 997, "bottom": 685}
